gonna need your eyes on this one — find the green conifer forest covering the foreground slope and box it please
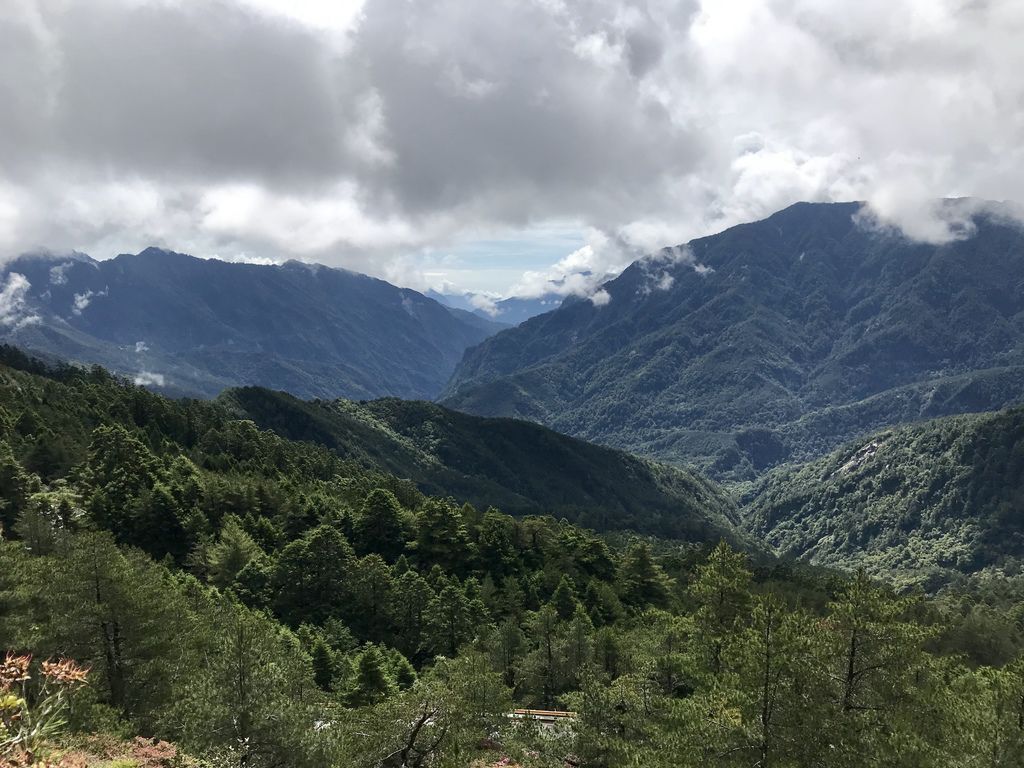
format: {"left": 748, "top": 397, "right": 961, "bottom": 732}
{"left": 0, "top": 348, "right": 1024, "bottom": 768}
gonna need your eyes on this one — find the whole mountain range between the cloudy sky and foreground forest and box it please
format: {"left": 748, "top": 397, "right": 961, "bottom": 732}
{"left": 0, "top": 202, "right": 1024, "bottom": 583}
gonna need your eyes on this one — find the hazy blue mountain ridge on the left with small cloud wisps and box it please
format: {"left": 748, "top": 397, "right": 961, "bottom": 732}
{"left": 0, "top": 248, "right": 500, "bottom": 397}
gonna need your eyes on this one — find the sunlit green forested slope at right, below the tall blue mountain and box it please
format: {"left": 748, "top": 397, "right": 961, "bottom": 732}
{"left": 743, "top": 408, "right": 1024, "bottom": 586}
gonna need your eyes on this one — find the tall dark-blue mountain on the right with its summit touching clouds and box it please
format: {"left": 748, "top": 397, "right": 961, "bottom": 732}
{"left": 441, "top": 202, "right": 1024, "bottom": 480}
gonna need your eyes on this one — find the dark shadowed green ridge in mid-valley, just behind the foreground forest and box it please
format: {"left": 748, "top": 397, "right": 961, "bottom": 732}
{"left": 219, "top": 387, "right": 751, "bottom": 546}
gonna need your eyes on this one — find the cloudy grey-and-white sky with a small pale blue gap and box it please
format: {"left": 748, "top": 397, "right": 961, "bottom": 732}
{"left": 0, "top": 0, "right": 1024, "bottom": 296}
